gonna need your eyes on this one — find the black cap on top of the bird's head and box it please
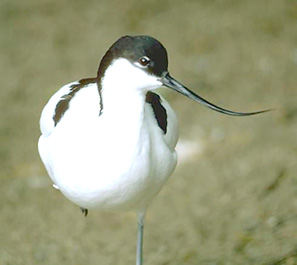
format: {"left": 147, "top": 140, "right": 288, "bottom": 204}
{"left": 98, "top": 36, "right": 168, "bottom": 78}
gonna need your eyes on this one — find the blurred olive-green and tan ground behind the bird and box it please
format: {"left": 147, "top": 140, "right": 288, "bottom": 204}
{"left": 0, "top": 0, "right": 297, "bottom": 265}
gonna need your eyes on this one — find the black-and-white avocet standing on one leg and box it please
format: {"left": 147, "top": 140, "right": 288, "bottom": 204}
{"left": 38, "top": 35, "right": 268, "bottom": 265}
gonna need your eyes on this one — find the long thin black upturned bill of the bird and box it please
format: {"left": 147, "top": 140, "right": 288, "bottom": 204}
{"left": 161, "top": 73, "right": 270, "bottom": 116}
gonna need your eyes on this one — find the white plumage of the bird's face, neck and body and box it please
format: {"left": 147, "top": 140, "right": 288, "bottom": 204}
{"left": 38, "top": 59, "right": 178, "bottom": 210}
